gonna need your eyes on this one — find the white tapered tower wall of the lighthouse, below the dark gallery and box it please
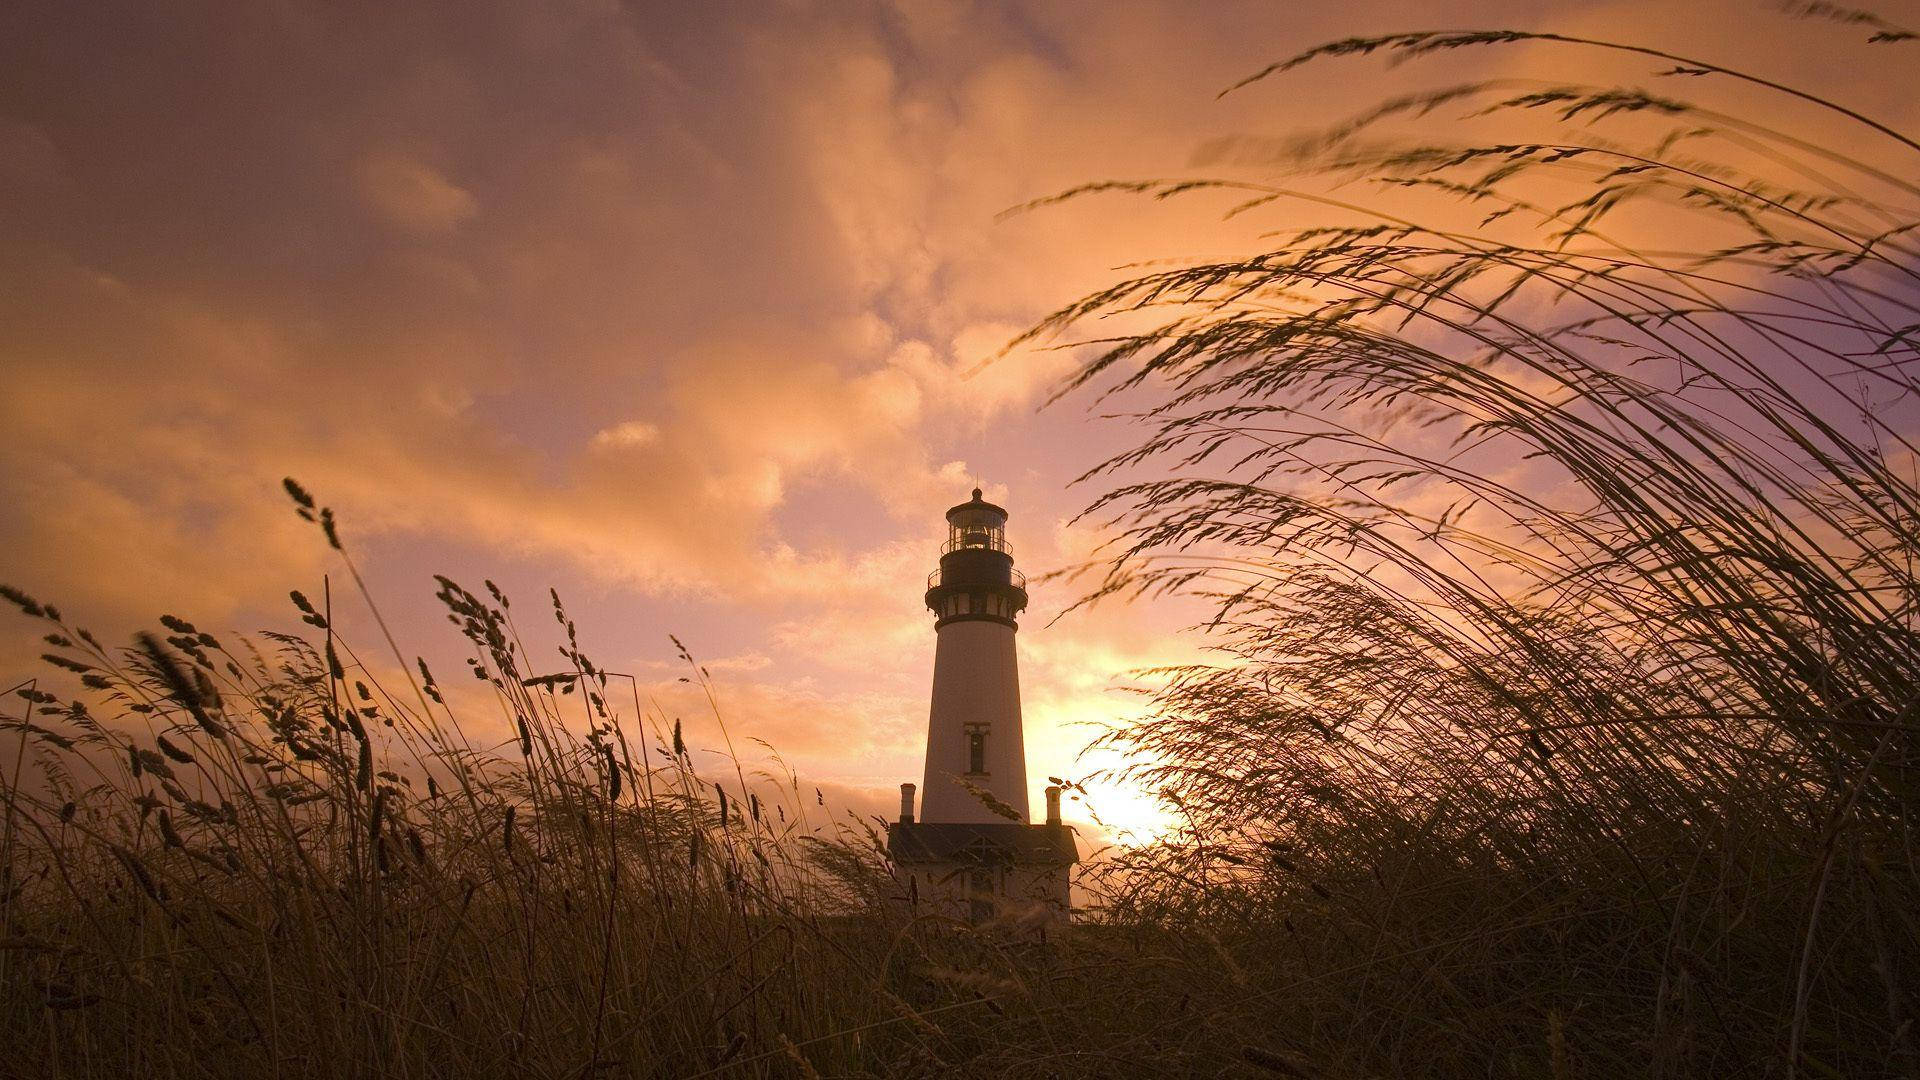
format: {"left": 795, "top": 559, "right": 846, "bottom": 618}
{"left": 920, "top": 619, "right": 1027, "bottom": 822}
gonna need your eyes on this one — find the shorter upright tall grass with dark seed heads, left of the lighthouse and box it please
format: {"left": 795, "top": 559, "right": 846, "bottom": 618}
{"left": 0, "top": 480, "right": 1128, "bottom": 1076}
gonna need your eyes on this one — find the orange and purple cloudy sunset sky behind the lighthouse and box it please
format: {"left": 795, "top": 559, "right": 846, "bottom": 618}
{"left": 0, "top": 0, "right": 1905, "bottom": 826}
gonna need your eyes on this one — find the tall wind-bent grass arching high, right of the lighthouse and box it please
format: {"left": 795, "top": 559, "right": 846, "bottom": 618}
{"left": 1035, "top": 14, "right": 1920, "bottom": 1076}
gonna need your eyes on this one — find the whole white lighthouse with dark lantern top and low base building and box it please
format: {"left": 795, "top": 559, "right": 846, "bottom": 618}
{"left": 887, "top": 488, "right": 1079, "bottom": 922}
